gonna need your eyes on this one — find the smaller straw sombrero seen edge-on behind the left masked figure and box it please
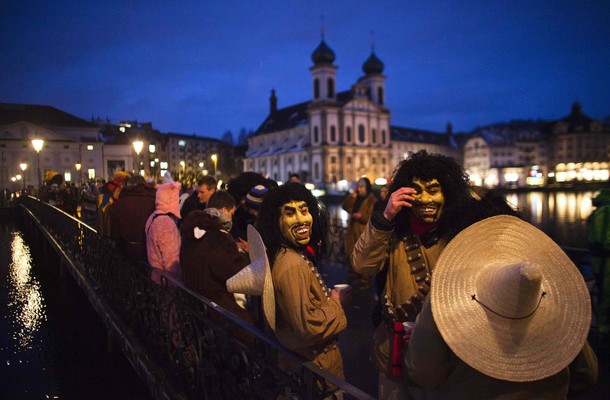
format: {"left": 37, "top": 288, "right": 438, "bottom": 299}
{"left": 227, "top": 225, "right": 275, "bottom": 331}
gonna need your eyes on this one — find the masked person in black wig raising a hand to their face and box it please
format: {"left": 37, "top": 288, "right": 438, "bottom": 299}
{"left": 351, "top": 150, "right": 516, "bottom": 399}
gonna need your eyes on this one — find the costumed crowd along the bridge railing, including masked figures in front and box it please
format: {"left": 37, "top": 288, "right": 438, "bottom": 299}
{"left": 30, "top": 151, "right": 607, "bottom": 399}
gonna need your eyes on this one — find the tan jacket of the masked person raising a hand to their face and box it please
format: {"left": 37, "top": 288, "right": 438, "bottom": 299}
{"left": 351, "top": 217, "right": 444, "bottom": 377}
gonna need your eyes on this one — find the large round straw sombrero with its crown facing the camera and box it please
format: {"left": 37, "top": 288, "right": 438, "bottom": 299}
{"left": 430, "top": 215, "right": 591, "bottom": 382}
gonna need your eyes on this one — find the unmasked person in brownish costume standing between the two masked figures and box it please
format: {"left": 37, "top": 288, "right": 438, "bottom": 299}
{"left": 341, "top": 178, "right": 377, "bottom": 288}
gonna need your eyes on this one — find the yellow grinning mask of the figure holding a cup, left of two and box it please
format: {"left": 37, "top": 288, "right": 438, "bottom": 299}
{"left": 280, "top": 201, "right": 313, "bottom": 247}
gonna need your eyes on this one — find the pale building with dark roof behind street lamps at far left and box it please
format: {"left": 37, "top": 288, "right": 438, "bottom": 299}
{"left": 0, "top": 103, "right": 121, "bottom": 188}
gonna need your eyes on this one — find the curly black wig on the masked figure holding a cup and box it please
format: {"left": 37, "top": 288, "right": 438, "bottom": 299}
{"left": 256, "top": 183, "right": 328, "bottom": 268}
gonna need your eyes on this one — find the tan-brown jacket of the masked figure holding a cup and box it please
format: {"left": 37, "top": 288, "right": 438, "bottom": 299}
{"left": 271, "top": 249, "right": 347, "bottom": 377}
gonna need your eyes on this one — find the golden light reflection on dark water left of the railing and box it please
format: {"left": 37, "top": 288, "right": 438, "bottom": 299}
{"left": 8, "top": 232, "right": 46, "bottom": 350}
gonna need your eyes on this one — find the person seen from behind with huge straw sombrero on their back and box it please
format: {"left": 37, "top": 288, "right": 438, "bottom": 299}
{"left": 404, "top": 215, "right": 598, "bottom": 400}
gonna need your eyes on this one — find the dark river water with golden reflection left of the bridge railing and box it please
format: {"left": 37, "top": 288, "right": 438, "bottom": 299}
{"left": 0, "top": 221, "right": 150, "bottom": 400}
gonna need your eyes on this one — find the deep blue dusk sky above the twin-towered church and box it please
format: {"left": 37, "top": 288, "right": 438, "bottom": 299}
{"left": 0, "top": 0, "right": 610, "bottom": 137}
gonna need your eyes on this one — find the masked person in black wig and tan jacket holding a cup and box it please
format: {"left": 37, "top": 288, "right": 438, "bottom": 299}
{"left": 256, "top": 183, "right": 349, "bottom": 396}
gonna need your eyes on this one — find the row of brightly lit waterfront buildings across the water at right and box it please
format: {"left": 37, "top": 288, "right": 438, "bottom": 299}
{"left": 463, "top": 103, "right": 610, "bottom": 187}
